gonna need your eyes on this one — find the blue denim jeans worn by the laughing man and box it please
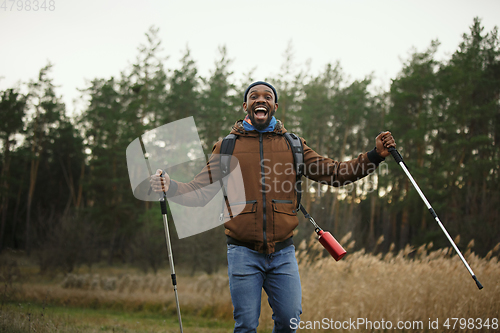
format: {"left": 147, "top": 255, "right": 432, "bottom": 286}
{"left": 227, "top": 244, "right": 302, "bottom": 333}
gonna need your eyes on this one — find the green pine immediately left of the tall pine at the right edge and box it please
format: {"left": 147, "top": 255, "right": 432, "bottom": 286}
{"left": 387, "top": 41, "right": 439, "bottom": 248}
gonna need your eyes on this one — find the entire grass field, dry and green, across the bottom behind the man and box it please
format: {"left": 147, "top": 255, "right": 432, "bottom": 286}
{"left": 0, "top": 232, "right": 500, "bottom": 332}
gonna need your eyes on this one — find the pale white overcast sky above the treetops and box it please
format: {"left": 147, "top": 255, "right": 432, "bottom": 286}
{"left": 0, "top": 0, "right": 500, "bottom": 111}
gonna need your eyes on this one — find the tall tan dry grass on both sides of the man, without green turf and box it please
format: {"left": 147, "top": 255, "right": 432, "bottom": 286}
{"left": 4, "top": 237, "right": 500, "bottom": 332}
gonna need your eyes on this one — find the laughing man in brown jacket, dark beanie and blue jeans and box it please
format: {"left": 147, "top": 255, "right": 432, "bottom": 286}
{"left": 151, "top": 81, "right": 396, "bottom": 333}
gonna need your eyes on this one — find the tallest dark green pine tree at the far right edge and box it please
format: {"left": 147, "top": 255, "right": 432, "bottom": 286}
{"left": 433, "top": 18, "right": 500, "bottom": 252}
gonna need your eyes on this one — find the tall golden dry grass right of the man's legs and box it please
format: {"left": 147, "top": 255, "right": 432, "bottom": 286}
{"left": 266, "top": 233, "right": 500, "bottom": 332}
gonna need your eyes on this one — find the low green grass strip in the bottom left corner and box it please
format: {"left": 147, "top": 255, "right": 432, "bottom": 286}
{"left": 0, "top": 302, "right": 233, "bottom": 333}
